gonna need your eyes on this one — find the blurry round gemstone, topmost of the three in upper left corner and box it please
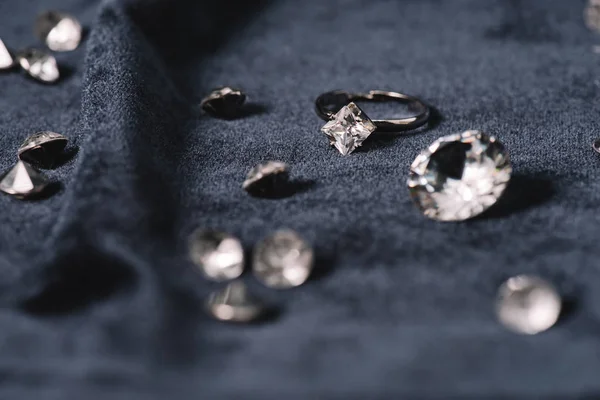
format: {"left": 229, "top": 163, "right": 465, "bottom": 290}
{"left": 35, "top": 11, "right": 83, "bottom": 51}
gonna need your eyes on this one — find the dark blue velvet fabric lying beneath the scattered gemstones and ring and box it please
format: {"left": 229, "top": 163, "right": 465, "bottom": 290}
{"left": 0, "top": 0, "right": 600, "bottom": 400}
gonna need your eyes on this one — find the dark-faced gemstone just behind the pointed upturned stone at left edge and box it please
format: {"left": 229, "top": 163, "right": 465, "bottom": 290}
{"left": 18, "top": 131, "right": 68, "bottom": 168}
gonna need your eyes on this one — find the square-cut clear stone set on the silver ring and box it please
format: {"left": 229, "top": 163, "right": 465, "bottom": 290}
{"left": 321, "top": 103, "right": 377, "bottom": 155}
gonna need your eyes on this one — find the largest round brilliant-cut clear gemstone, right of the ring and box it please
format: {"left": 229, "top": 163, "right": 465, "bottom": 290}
{"left": 408, "top": 131, "right": 512, "bottom": 221}
